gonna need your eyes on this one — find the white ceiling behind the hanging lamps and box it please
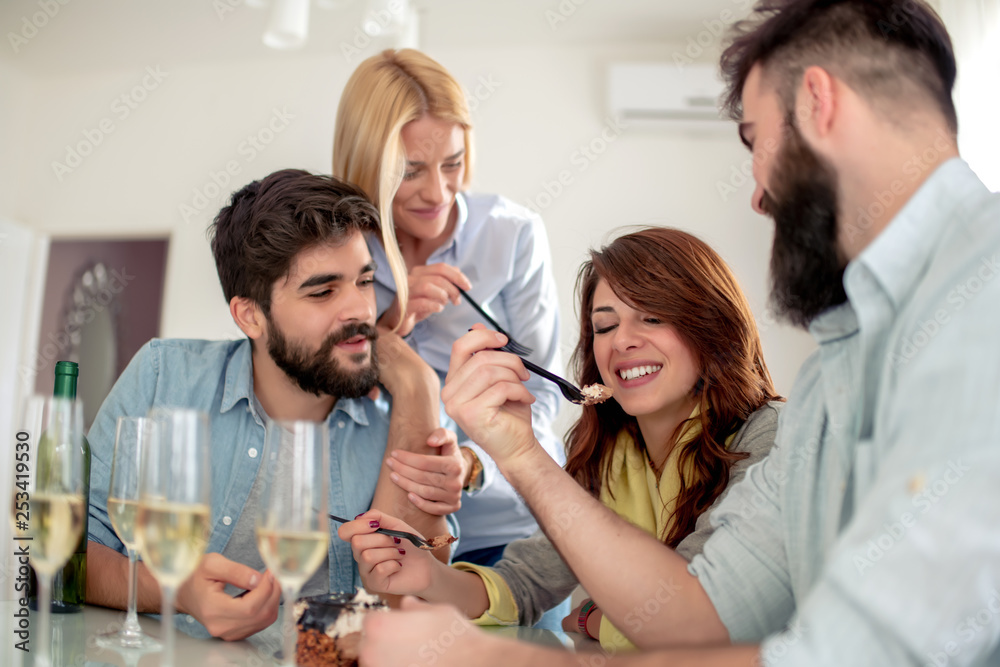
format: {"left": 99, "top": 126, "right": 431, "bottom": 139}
{"left": 0, "top": 0, "right": 748, "bottom": 76}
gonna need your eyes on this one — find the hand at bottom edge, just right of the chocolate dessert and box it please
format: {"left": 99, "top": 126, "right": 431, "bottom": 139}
{"left": 360, "top": 597, "right": 498, "bottom": 667}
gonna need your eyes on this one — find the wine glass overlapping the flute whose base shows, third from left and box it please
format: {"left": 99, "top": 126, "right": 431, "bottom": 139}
{"left": 136, "top": 408, "right": 212, "bottom": 667}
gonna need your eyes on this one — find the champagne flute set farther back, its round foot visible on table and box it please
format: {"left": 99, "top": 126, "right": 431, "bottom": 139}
{"left": 97, "top": 417, "right": 160, "bottom": 651}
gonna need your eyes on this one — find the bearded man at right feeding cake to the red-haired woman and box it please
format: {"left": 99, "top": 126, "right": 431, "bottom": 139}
{"left": 362, "top": 0, "right": 1000, "bottom": 667}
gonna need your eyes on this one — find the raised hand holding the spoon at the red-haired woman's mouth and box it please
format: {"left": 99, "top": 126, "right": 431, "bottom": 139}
{"left": 441, "top": 325, "right": 541, "bottom": 467}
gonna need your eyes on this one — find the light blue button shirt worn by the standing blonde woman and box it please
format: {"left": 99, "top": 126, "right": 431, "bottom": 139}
{"left": 368, "top": 193, "right": 566, "bottom": 551}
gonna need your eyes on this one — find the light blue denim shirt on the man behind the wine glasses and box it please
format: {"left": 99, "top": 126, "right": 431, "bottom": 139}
{"left": 88, "top": 339, "right": 458, "bottom": 620}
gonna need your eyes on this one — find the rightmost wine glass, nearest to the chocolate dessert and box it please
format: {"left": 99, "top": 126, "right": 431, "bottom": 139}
{"left": 257, "top": 420, "right": 330, "bottom": 665}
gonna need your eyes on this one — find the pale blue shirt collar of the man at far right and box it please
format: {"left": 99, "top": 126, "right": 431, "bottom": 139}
{"left": 848, "top": 158, "right": 986, "bottom": 310}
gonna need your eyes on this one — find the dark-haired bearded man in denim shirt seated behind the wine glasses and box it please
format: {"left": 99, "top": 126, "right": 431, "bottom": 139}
{"left": 87, "top": 169, "right": 462, "bottom": 640}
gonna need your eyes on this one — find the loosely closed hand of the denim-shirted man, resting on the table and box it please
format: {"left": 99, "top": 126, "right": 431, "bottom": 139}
{"left": 177, "top": 553, "right": 281, "bottom": 641}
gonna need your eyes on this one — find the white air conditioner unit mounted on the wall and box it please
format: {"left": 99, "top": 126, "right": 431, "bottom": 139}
{"left": 608, "top": 62, "right": 724, "bottom": 123}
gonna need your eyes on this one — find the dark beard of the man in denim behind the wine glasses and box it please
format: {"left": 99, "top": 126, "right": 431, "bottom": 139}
{"left": 267, "top": 320, "right": 378, "bottom": 398}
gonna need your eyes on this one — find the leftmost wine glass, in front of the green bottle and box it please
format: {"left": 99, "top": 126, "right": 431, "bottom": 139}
{"left": 11, "top": 396, "right": 87, "bottom": 667}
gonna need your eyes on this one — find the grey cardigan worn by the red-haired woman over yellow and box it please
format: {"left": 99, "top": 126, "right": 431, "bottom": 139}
{"left": 480, "top": 401, "right": 783, "bottom": 625}
